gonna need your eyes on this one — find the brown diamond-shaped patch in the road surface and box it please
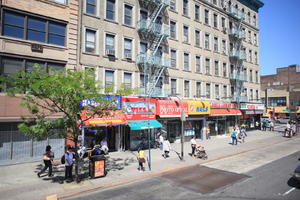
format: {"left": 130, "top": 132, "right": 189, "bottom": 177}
{"left": 161, "top": 165, "right": 248, "bottom": 194}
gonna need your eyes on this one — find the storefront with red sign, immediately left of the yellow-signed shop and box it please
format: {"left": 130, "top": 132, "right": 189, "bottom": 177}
{"left": 156, "top": 99, "right": 188, "bottom": 143}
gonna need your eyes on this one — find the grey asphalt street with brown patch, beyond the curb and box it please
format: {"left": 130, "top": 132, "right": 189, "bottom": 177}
{"left": 63, "top": 135, "right": 300, "bottom": 200}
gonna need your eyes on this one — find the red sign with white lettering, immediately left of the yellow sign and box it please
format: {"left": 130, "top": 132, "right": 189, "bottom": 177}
{"left": 156, "top": 100, "right": 188, "bottom": 117}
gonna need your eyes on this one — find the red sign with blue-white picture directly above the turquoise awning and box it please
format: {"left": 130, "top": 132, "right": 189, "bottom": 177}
{"left": 122, "top": 97, "right": 156, "bottom": 120}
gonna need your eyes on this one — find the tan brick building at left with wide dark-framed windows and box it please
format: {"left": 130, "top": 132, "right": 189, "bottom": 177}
{"left": 0, "top": 0, "right": 79, "bottom": 162}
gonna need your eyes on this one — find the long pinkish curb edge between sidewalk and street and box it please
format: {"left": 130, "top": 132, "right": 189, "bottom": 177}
{"left": 45, "top": 138, "right": 296, "bottom": 200}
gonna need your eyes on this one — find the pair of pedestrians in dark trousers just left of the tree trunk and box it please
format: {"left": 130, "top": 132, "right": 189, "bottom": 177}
{"left": 37, "top": 145, "right": 75, "bottom": 181}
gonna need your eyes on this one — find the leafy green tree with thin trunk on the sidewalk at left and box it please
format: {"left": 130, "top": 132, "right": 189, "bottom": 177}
{"left": 0, "top": 65, "right": 133, "bottom": 180}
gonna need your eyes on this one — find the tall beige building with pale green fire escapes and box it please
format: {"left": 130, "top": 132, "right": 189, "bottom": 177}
{"left": 79, "top": 0, "right": 263, "bottom": 148}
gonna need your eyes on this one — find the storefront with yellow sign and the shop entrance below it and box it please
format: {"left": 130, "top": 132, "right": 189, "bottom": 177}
{"left": 184, "top": 101, "right": 210, "bottom": 140}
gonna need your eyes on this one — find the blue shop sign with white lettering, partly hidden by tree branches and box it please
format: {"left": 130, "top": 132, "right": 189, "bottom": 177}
{"left": 80, "top": 95, "right": 121, "bottom": 110}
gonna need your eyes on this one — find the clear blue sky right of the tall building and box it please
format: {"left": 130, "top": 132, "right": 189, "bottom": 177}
{"left": 259, "top": 0, "right": 300, "bottom": 75}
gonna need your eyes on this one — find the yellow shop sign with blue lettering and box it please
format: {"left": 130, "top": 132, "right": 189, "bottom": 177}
{"left": 187, "top": 101, "right": 210, "bottom": 115}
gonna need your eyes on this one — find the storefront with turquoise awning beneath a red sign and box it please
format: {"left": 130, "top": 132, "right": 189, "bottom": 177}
{"left": 122, "top": 97, "right": 162, "bottom": 150}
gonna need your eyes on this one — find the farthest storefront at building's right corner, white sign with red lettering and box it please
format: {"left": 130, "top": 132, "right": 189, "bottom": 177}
{"left": 240, "top": 103, "right": 265, "bottom": 129}
